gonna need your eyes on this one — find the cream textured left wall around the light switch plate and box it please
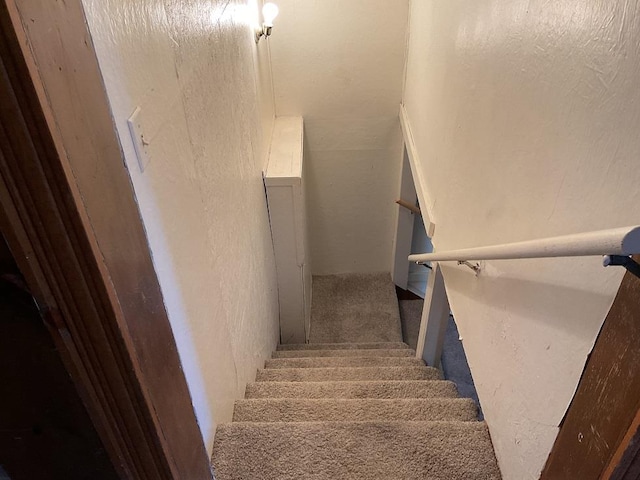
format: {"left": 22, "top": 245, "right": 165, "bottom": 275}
{"left": 84, "top": 0, "right": 278, "bottom": 453}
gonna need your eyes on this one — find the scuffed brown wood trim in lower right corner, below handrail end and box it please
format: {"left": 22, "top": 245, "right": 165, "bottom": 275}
{"left": 541, "top": 260, "right": 640, "bottom": 480}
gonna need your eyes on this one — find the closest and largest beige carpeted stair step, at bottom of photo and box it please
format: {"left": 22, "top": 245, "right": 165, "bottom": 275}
{"left": 213, "top": 422, "right": 500, "bottom": 480}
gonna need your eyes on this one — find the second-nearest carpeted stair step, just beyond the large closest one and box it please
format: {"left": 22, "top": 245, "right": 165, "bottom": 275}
{"left": 233, "top": 398, "right": 478, "bottom": 422}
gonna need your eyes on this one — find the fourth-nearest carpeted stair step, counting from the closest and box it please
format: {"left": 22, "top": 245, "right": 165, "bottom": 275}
{"left": 256, "top": 367, "right": 442, "bottom": 382}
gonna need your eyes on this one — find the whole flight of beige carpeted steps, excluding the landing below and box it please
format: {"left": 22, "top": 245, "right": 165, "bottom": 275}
{"left": 213, "top": 342, "right": 500, "bottom": 480}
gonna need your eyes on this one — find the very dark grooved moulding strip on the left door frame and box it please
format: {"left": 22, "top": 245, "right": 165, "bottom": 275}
{"left": 0, "top": 12, "right": 159, "bottom": 478}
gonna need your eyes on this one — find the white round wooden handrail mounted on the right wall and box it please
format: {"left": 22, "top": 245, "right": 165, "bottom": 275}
{"left": 409, "top": 226, "right": 640, "bottom": 263}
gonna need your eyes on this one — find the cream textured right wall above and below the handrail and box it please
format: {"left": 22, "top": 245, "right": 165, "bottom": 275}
{"left": 404, "top": 0, "right": 640, "bottom": 480}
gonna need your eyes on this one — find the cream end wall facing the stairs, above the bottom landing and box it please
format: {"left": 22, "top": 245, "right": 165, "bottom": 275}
{"left": 270, "top": 0, "right": 408, "bottom": 274}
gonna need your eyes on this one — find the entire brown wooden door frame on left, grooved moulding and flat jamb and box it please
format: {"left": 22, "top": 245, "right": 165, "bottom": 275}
{"left": 0, "top": 0, "right": 212, "bottom": 480}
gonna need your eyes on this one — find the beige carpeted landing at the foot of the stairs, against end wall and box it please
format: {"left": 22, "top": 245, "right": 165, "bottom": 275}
{"left": 309, "top": 273, "right": 402, "bottom": 343}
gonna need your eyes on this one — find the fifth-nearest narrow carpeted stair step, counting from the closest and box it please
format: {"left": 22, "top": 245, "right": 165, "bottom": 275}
{"left": 264, "top": 357, "right": 424, "bottom": 368}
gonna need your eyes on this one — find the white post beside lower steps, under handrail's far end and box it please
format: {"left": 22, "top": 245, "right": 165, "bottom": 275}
{"left": 416, "top": 262, "right": 450, "bottom": 367}
